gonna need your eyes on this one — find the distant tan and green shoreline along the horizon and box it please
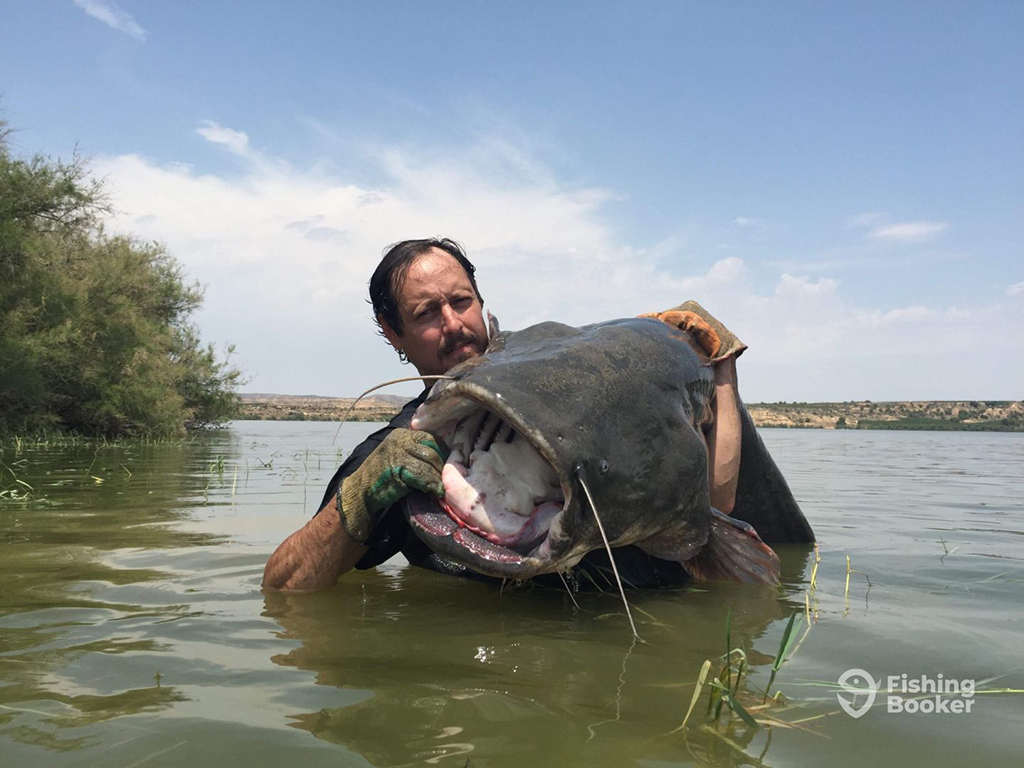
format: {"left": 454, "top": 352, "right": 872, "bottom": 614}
{"left": 239, "top": 394, "right": 1024, "bottom": 432}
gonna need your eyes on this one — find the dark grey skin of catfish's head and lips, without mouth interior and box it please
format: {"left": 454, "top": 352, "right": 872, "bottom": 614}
{"left": 406, "top": 318, "right": 790, "bottom": 581}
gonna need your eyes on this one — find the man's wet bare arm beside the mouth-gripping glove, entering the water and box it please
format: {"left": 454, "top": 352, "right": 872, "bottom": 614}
{"left": 263, "top": 499, "right": 367, "bottom": 592}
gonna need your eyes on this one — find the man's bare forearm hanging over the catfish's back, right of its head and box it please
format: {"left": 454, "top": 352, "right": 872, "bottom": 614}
{"left": 708, "top": 356, "right": 742, "bottom": 515}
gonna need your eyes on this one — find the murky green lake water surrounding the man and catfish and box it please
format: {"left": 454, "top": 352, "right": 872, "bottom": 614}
{"left": 0, "top": 422, "right": 1024, "bottom": 766}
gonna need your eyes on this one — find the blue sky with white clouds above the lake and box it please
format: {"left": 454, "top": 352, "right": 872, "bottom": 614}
{"left": 0, "top": 0, "right": 1024, "bottom": 400}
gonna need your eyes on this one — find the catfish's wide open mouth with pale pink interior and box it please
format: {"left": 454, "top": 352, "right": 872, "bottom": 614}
{"left": 407, "top": 396, "right": 565, "bottom": 575}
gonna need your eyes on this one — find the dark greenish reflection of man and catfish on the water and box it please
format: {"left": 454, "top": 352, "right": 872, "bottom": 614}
{"left": 266, "top": 568, "right": 788, "bottom": 765}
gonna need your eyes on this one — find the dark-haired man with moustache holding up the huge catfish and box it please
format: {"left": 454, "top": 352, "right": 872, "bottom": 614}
{"left": 263, "top": 239, "right": 742, "bottom": 591}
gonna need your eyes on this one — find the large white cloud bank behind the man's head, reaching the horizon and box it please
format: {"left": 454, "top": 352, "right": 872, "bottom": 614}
{"left": 95, "top": 122, "right": 1024, "bottom": 401}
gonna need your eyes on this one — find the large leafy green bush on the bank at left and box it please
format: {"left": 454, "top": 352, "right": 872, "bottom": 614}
{"left": 0, "top": 121, "right": 242, "bottom": 437}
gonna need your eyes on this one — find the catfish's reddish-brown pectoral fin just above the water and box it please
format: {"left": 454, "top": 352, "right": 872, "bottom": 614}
{"left": 682, "top": 509, "right": 779, "bottom": 584}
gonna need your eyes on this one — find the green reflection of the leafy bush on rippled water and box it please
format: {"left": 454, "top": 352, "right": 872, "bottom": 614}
{"left": 0, "top": 436, "right": 222, "bottom": 752}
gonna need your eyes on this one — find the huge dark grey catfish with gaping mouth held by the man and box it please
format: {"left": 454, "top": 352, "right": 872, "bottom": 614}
{"left": 404, "top": 318, "right": 813, "bottom": 583}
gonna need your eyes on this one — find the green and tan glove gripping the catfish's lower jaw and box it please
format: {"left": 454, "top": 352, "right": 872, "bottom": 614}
{"left": 337, "top": 429, "right": 447, "bottom": 544}
